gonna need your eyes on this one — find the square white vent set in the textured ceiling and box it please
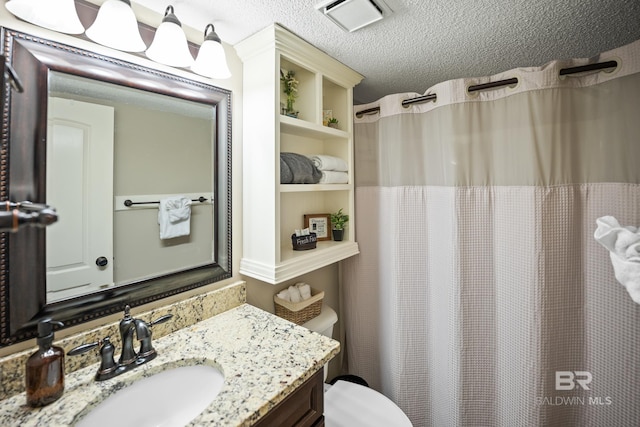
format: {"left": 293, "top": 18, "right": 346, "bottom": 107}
{"left": 316, "top": 0, "right": 391, "bottom": 32}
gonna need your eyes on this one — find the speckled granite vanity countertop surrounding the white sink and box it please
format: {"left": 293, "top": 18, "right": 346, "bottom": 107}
{"left": 0, "top": 304, "right": 339, "bottom": 427}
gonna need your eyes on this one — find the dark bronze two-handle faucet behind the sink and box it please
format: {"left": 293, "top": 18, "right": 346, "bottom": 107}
{"left": 67, "top": 305, "right": 173, "bottom": 381}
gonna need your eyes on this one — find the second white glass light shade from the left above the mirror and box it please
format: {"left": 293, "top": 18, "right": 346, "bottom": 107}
{"left": 85, "top": 0, "right": 147, "bottom": 52}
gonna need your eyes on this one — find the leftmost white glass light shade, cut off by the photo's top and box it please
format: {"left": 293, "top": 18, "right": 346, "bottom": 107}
{"left": 5, "top": 0, "right": 84, "bottom": 34}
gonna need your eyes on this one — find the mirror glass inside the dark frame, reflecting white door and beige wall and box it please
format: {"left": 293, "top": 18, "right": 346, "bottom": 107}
{"left": 46, "top": 72, "right": 215, "bottom": 303}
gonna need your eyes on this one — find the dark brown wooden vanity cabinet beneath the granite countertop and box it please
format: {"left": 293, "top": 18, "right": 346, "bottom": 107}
{"left": 254, "top": 369, "right": 324, "bottom": 427}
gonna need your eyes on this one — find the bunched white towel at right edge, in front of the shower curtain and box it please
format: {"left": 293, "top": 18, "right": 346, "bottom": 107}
{"left": 593, "top": 216, "right": 640, "bottom": 304}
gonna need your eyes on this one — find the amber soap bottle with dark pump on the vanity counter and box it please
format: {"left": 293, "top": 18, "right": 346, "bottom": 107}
{"left": 25, "top": 317, "right": 64, "bottom": 407}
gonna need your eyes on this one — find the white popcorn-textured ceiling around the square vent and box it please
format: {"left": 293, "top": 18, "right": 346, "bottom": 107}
{"left": 134, "top": 0, "right": 640, "bottom": 104}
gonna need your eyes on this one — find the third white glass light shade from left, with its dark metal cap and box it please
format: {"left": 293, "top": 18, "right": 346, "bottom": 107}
{"left": 147, "top": 6, "right": 193, "bottom": 67}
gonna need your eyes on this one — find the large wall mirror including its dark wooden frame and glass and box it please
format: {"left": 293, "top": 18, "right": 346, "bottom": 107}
{"left": 0, "top": 28, "right": 231, "bottom": 345}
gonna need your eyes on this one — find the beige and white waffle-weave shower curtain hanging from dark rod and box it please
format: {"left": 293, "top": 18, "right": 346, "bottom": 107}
{"left": 342, "top": 41, "right": 640, "bottom": 427}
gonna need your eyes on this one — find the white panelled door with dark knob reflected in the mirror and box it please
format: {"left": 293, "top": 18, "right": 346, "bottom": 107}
{"left": 46, "top": 97, "right": 114, "bottom": 303}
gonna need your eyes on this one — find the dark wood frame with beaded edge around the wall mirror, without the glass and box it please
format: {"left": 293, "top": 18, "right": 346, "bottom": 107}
{"left": 0, "top": 28, "right": 232, "bottom": 346}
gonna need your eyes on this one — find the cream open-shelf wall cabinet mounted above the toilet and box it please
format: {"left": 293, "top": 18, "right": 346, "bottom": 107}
{"left": 235, "top": 24, "right": 362, "bottom": 284}
